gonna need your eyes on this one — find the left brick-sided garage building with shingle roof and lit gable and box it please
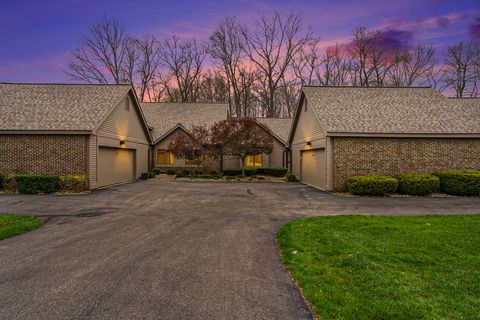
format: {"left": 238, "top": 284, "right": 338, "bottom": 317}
{"left": 0, "top": 83, "right": 151, "bottom": 189}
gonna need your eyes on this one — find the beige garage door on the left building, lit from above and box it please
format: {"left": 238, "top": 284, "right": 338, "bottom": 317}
{"left": 97, "top": 147, "right": 135, "bottom": 187}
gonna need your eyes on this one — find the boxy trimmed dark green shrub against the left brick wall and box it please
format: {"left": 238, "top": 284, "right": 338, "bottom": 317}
{"left": 13, "top": 174, "right": 60, "bottom": 194}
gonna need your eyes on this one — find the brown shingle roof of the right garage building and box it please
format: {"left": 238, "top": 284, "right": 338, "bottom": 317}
{"left": 303, "top": 87, "right": 480, "bottom": 134}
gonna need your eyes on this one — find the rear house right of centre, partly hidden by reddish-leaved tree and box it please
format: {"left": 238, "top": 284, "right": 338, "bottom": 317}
{"left": 223, "top": 118, "right": 292, "bottom": 169}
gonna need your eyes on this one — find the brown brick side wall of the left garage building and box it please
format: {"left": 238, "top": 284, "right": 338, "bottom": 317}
{"left": 0, "top": 134, "right": 88, "bottom": 175}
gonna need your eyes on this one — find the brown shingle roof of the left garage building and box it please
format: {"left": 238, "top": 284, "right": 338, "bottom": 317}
{"left": 0, "top": 83, "right": 131, "bottom": 131}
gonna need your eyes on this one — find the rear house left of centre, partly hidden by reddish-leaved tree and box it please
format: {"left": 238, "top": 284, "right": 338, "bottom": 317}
{"left": 141, "top": 102, "right": 228, "bottom": 171}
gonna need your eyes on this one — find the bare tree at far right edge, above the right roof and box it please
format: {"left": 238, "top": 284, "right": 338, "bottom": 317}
{"left": 440, "top": 42, "right": 478, "bottom": 98}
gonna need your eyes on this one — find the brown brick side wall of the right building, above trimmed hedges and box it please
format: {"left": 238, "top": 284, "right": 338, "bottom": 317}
{"left": 332, "top": 138, "right": 480, "bottom": 191}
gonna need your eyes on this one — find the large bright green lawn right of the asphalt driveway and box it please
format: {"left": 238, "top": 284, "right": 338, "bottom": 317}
{"left": 277, "top": 215, "right": 480, "bottom": 320}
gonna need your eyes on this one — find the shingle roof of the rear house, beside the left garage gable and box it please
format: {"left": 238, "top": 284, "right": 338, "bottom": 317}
{"left": 140, "top": 102, "right": 228, "bottom": 141}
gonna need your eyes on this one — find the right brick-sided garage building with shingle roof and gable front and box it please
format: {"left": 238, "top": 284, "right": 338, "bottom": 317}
{"left": 289, "top": 87, "right": 480, "bottom": 191}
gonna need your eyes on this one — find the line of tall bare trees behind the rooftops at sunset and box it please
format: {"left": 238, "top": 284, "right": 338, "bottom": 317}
{"left": 65, "top": 12, "right": 480, "bottom": 117}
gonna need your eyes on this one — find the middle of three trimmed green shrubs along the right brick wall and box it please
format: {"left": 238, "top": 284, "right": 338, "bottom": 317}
{"left": 394, "top": 173, "right": 440, "bottom": 196}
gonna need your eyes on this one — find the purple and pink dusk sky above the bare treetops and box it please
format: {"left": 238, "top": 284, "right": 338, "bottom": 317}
{"left": 0, "top": 0, "right": 480, "bottom": 83}
